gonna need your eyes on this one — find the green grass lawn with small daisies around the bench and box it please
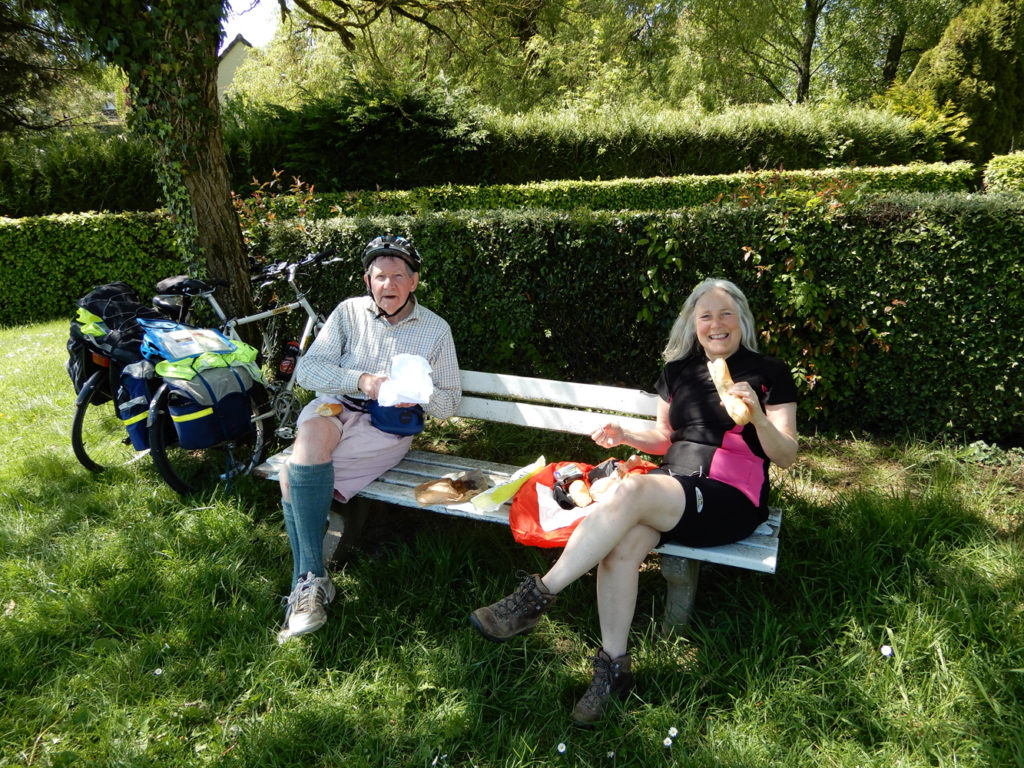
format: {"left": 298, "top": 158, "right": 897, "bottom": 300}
{"left": 0, "top": 323, "right": 1024, "bottom": 768}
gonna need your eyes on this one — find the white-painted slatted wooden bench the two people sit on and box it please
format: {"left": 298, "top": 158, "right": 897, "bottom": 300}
{"left": 255, "top": 371, "right": 781, "bottom": 631}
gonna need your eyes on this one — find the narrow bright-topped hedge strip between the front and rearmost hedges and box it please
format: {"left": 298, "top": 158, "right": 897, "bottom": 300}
{"left": 253, "top": 161, "right": 978, "bottom": 218}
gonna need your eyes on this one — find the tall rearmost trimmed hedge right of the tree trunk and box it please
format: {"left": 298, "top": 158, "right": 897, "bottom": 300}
{"left": 225, "top": 100, "right": 961, "bottom": 193}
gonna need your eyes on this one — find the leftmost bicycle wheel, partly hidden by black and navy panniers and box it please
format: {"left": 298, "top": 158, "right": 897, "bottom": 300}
{"left": 71, "top": 371, "right": 146, "bottom": 472}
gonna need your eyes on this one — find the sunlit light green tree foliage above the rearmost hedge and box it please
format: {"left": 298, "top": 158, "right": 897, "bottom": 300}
{"left": 222, "top": 0, "right": 969, "bottom": 113}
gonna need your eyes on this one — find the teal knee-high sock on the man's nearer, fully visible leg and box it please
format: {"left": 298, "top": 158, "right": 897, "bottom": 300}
{"left": 288, "top": 462, "right": 334, "bottom": 579}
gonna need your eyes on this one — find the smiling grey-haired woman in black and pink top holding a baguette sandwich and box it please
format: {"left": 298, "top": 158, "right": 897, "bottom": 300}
{"left": 469, "top": 279, "right": 798, "bottom": 726}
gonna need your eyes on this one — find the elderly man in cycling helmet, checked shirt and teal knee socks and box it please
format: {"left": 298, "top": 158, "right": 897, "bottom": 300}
{"left": 281, "top": 238, "right": 462, "bottom": 639}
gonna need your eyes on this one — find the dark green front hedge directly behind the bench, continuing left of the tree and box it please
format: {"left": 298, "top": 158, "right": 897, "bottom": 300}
{"left": 0, "top": 194, "right": 1024, "bottom": 442}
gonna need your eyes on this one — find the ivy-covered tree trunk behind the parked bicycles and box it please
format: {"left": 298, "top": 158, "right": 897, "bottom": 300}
{"left": 61, "top": 0, "right": 252, "bottom": 319}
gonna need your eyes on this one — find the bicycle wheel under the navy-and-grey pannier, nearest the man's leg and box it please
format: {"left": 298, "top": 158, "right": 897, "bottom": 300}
{"left": 147, "top": 384, "right": 273, "bottom": 496}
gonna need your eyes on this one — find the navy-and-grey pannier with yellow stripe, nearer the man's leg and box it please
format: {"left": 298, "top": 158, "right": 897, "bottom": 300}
{"left": 164, "top": 366, "right": 253, "bottom": 450}
